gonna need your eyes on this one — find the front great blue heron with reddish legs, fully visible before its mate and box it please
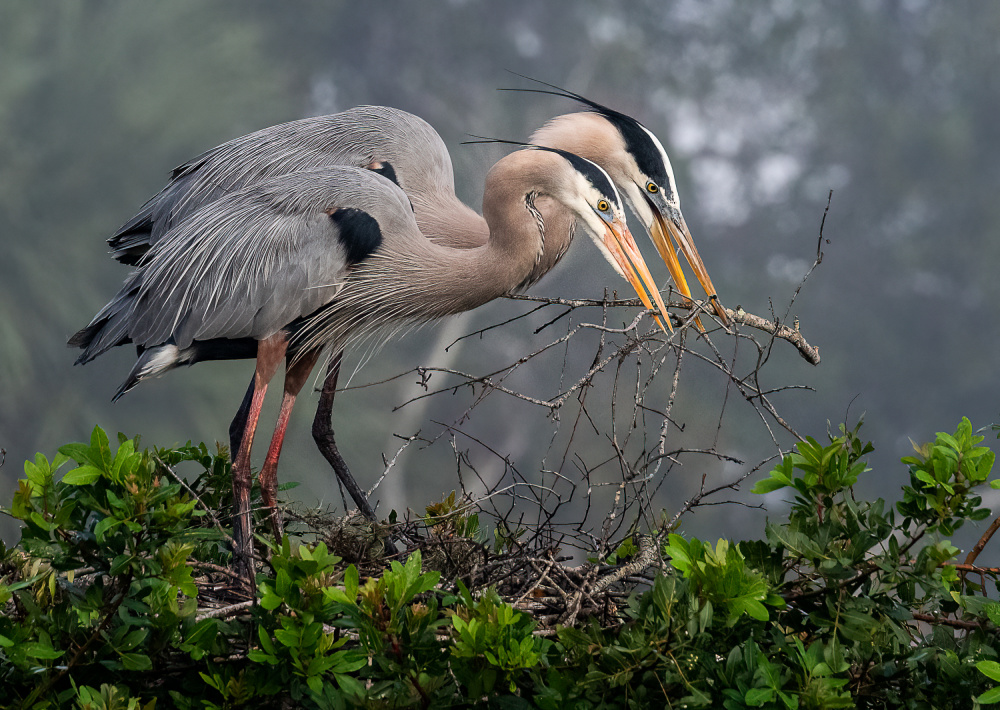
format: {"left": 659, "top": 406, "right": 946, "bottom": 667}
{"left": 70, "top": 148, "right": 666, "bottom": 581}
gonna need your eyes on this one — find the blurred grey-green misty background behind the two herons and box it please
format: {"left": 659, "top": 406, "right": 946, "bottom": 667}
{"left": 0, "top": 0, "right": 1000, "bottom": 546}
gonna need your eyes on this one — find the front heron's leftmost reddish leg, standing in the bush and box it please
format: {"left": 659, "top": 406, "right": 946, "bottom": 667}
{"left": 233, "top": 332, "right": 288, "bottom": 594}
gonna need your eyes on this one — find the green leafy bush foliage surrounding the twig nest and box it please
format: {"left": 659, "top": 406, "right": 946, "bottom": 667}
{"left": 0, "top": 420, "right": 1000, "bottom": 710}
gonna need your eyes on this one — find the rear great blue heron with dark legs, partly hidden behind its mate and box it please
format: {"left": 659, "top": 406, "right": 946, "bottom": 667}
{"left": 97, "top": 96, "right": 727, "bottom": 518}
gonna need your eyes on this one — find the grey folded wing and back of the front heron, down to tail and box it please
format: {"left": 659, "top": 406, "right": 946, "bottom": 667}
{"left": 70, "top": 167, "right": 419, "bottom": 362}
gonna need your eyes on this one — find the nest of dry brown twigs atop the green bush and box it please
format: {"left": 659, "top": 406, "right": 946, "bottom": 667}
{"left": 196, "top": 500, "right": 661, "bottom": 633}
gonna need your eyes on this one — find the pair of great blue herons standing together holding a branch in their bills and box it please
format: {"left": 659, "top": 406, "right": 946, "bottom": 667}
{"left": 69, "top": 82, "right": 727, "bottom": 588}
